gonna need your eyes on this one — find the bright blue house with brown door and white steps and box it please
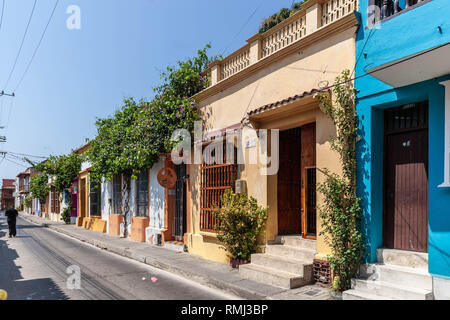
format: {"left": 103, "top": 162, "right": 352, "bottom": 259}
{"left": 344, "top": 0, "right": 450, "bottom": 299}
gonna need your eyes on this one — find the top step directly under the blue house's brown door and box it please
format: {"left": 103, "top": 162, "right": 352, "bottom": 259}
{"left": 377, "top": 249, "right": 428, "bottom": 271}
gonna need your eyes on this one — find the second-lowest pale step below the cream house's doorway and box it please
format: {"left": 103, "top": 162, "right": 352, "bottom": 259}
{"left": 252, "top": 253, "right": 312, "bottom": 278}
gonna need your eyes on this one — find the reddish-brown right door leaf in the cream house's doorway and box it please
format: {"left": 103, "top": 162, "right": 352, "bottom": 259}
{"left": 301, "top": 123, "right": 316, "bottom": 238}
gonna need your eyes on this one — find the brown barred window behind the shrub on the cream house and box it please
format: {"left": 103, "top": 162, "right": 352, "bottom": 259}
{"left": 200, "top": 144, "right": 237, "bottom": 232}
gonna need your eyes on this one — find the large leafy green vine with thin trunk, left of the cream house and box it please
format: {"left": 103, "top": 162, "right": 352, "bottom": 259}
{"left": 87, "top": 45, "right": 216, "bottom": 237}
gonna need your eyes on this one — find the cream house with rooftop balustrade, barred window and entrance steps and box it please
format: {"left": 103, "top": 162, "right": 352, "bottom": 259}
{"left": 186, "top": 0, "right": 358, "bottom": 288}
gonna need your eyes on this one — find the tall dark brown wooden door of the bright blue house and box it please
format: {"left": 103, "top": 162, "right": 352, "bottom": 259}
{"left": 383, "top": 103, "right": 428, "bottom": 252}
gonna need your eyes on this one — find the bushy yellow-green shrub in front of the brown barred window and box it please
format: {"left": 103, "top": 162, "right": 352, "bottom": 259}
{"left": 216, "top": 189, "right": 267, "bottom": 261}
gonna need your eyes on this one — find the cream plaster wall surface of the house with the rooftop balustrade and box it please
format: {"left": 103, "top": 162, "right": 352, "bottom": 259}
{"left": 188, "top": 28, "right": 356, "bottom": 262}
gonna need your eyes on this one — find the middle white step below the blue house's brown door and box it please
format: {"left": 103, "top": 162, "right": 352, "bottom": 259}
{"left": 360, "top": 264, "right": 433, "bottom": 291}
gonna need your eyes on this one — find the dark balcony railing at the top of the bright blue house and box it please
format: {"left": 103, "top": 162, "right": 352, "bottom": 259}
{"left": 369, "top": 0, "right": 431, "bottom": 24}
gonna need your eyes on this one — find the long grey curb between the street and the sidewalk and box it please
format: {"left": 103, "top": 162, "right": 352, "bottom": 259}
{"left": 20, "top": 215, "right": 269, "bottom": 300}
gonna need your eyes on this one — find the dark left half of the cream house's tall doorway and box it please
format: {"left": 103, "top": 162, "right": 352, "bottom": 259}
{"left": 278, "top": 128, "right": 302, "bottom": 235}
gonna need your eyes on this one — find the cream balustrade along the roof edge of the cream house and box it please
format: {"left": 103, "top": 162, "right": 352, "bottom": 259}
{"left": 199, "top": 0, "right": 358, "bottom": 96}
